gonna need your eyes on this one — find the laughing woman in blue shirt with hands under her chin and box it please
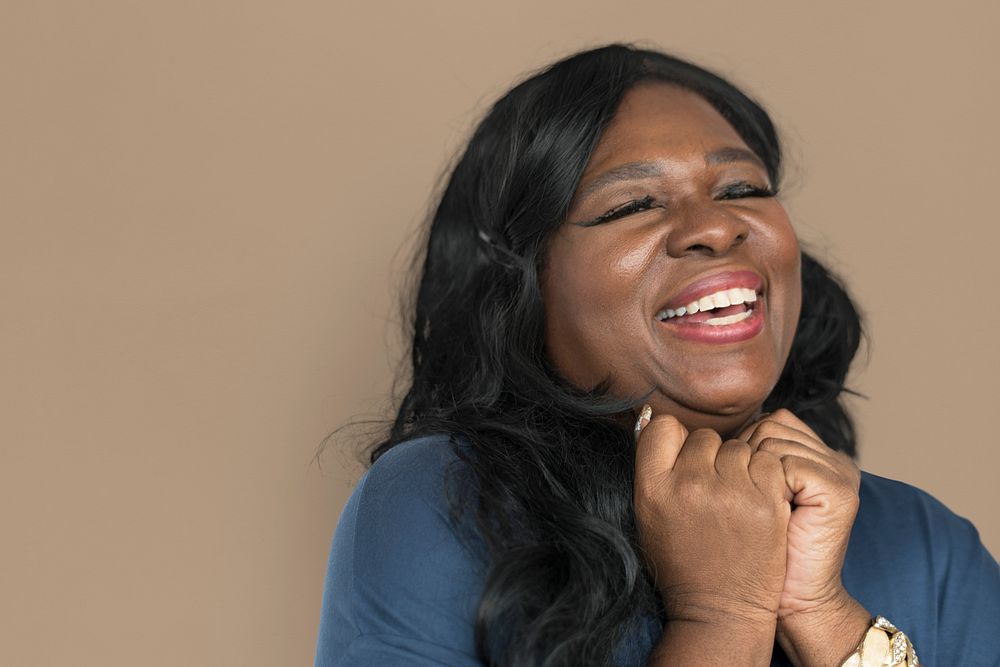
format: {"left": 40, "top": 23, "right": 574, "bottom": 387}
{"left": 316, "top": 45, "right": 1000, "bottom": 667}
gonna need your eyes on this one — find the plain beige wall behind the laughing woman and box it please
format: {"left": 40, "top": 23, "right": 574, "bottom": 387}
{"left": 0, "top": 0, "right": 1000, "bottom": 666}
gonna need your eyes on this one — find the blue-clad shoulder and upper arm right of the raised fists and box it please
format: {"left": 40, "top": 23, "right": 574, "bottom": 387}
{"left": 843, "top": 472, "right": 1000, "bottom": 665}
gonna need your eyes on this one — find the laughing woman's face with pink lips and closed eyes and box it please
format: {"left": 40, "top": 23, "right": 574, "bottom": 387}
{"left": 542, "top": 83, "right": 801, "bottom": 434}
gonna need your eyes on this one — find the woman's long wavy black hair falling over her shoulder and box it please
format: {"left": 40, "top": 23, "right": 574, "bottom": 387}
{"left": 371, "top": 44, "right": 862, "bottom": 666}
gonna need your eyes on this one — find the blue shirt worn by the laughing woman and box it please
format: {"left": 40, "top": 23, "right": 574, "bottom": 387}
{"left": 316, "top": 436, "right": 1000, "bottom": 667}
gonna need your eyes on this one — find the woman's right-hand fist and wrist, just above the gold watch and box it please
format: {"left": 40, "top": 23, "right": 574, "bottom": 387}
{"left": 739, "top": 409, "right": 871, "bottom": 665}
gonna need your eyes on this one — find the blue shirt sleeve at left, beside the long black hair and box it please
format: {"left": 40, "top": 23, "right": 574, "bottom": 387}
{"left": 315, "top": 437, "right": 483, "bottom": 667}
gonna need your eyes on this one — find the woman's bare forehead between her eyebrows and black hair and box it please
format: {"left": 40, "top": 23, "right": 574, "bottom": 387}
{"left": 582, "top": 82, "right": 746, "bottom": 181}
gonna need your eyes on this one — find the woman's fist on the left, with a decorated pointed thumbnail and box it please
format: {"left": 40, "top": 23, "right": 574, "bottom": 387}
{"left": 633, "top": 415, "right": 791, "bottom": 636}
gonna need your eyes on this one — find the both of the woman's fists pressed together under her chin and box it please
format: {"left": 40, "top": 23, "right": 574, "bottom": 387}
{"left": 634, "top": 410, "right": 866, "bottom": 664}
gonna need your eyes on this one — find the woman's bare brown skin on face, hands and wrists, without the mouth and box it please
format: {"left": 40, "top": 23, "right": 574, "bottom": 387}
{"left": 542, "top": 83, "right": 871, "bottom": 667}
